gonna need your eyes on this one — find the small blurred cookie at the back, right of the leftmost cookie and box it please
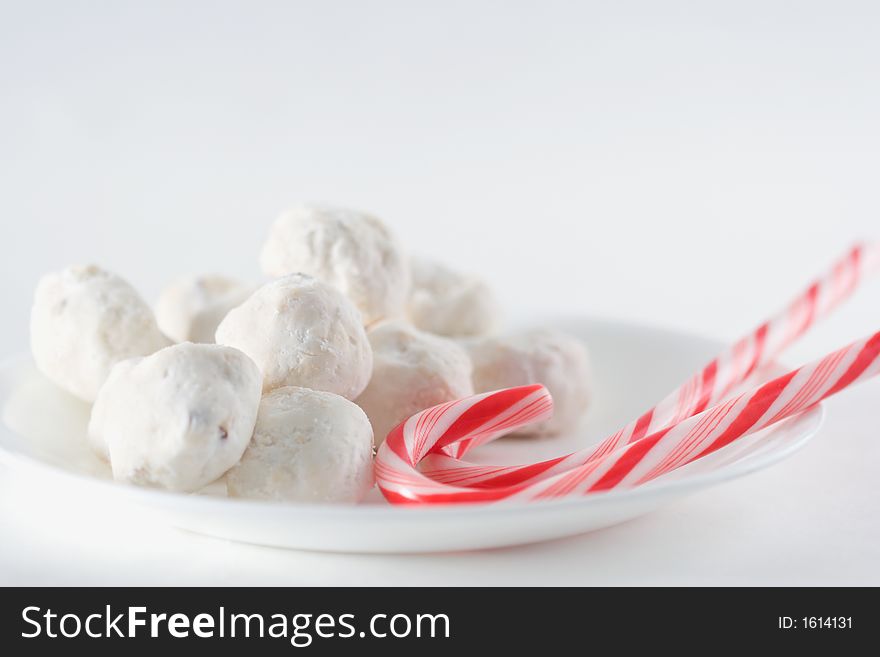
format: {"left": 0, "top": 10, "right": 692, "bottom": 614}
{"left": 156, "top": 274, "right": 254, "bottom": 343}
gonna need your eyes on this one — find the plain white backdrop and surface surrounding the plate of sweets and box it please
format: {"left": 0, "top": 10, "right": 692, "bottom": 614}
{"left": 0, "top": 0, "right": 880, "bottom": 585}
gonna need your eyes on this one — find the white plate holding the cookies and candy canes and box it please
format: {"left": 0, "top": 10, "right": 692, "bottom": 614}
{"left": 0, "top": 319, "right": 823, "bottom": 552}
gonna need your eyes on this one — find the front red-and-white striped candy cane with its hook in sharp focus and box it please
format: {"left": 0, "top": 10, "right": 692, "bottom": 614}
{"left": 376, "top": 332, "right": 880, "bottom": 504}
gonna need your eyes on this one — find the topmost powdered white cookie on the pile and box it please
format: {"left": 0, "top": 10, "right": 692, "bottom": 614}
{"left": 260, "top": 205, "right": 409, "bottom": 324}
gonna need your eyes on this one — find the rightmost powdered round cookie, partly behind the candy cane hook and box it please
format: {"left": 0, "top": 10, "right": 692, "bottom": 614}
{"left": 466, "top": 329, "right": 591, "bottom": 435}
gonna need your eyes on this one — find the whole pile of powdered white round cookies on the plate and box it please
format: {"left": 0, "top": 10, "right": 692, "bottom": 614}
{"left": 31, "top": 205, "right": 590, "bottom": 503}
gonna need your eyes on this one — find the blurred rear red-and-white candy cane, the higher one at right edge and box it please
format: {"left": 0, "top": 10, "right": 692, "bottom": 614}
{"left": 434, "top": 244, "right": 880, "bottom": 487}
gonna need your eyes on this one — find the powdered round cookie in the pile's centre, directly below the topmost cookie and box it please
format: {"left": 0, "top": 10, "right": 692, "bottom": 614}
{"left": 216, "top": 274, "right": 373, "bottom": 399}
